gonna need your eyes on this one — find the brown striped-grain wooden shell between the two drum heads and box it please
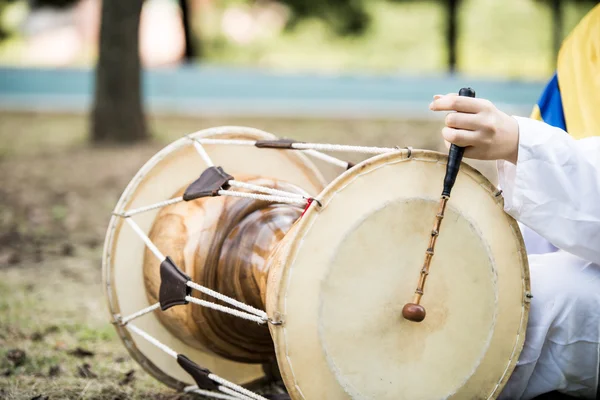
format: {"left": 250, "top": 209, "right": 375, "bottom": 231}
{"left": 144, "top": 176, "right": 305, "bottom": 363}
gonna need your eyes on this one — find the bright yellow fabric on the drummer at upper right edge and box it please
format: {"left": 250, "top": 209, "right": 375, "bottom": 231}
{"left": 556, "top": 4, "right": 600, "bottom": 139}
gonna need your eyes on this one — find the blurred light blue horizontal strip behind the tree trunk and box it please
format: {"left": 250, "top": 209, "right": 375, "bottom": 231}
{"left": 0, "top": 66, "right": 544, "bottom": 118}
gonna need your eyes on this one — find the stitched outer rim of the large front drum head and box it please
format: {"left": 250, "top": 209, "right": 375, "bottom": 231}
{"left": 267, "top": 150, "right": 531, "bottom": 399}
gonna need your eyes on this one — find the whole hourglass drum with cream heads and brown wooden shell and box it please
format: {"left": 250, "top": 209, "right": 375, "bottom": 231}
{"left": 104, "top": 127, "right": 530, "bottom": 400}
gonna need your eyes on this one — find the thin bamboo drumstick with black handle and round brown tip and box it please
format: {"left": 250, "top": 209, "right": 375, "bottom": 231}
{"left": 402, "top": 88, "right": 475, "bottom": 322}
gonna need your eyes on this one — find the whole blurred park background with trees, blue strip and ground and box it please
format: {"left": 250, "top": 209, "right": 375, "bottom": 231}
{"left": 0, "top": 0, "right": 597, "bottom": 399}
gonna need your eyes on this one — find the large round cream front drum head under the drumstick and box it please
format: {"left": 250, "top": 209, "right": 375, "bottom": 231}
{"left": 267, "top": 151, "right": 529, "bottom": 400}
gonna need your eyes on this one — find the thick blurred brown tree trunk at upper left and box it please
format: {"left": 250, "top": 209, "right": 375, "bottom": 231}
{"left": 92, "top": 0, "right": 148, "bottom": 143}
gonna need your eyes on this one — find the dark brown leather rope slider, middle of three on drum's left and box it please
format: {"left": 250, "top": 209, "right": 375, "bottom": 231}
{"left": 158, "top": 256, "right": 192, "bottom": 311}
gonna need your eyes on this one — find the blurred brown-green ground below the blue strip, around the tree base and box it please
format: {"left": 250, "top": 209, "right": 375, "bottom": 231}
{"left": 0, "top": 113, "right": 500, "bottom": 399}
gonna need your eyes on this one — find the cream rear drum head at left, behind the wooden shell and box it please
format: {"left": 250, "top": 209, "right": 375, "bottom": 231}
{"left": 103, "top": 127, "right": 325, "bottom": 388}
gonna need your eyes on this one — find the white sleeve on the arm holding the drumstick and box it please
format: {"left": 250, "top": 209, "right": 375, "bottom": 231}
{"left": 497, "top": 117, "right": 600, "bottom": 264}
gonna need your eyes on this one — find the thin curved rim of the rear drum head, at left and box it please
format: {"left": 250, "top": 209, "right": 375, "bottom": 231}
{"left": 102, "top": 126, "right": 327, "bottom": 390}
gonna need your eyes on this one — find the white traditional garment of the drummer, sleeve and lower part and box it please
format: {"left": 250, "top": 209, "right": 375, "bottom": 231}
{"left": 498, "top": 117, "right": 600, "bottom": 399}
